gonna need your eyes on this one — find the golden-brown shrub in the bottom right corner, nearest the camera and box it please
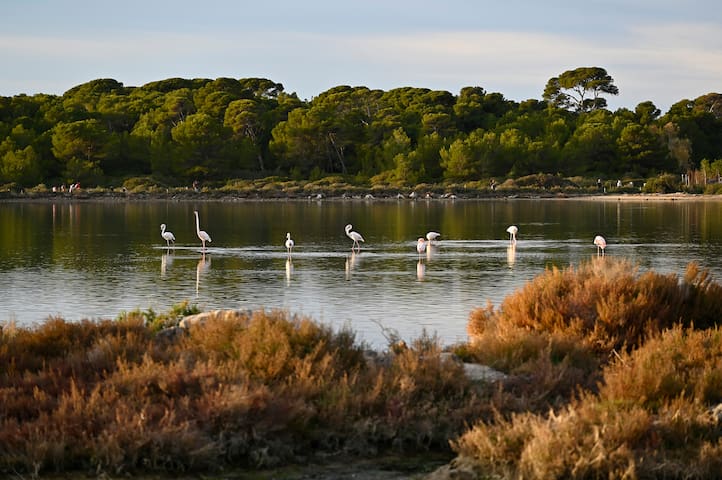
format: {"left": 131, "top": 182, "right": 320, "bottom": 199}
{"left": 454, "top": 326, "right": 722, "bottom": 479}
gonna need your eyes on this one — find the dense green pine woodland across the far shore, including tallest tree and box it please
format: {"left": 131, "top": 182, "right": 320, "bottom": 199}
{"left": 0, "top": 67, "right": 722, "bottom": 187}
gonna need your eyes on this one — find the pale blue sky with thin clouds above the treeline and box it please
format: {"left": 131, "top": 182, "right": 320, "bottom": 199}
{"left": 0, "top": 0, "right": 722, "bottom": 113}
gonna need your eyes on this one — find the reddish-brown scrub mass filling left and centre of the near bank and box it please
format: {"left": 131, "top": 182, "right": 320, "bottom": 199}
{"left": 0, "top": 311, "right": 488, "bottom": 476}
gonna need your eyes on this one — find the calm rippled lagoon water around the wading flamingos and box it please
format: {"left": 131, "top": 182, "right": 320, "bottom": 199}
{"left": 0, "top": 199, "right": 722, "bottom": 347}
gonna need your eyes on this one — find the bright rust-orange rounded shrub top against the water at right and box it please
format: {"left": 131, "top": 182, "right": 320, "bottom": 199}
{"left": 468, "top": 257, "right": 722, "bottom": 358}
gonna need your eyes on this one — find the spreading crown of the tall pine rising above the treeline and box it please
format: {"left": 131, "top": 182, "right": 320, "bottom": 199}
{"left": 544, "top": 67, "right": 619, "bottom": 112}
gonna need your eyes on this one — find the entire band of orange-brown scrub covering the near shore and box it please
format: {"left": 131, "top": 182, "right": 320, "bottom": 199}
{"left": 0, "top": 257, "right": 722, "bottom": 479}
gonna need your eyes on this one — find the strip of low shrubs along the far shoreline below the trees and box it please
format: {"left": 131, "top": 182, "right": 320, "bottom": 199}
{"left": 5, "top": 174, "right": 722, "bottom": 200}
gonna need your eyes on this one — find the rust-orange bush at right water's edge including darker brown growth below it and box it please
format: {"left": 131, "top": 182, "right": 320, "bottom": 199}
{"left": 457, "top": 257, "right": 722, "bottom": 412}
